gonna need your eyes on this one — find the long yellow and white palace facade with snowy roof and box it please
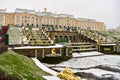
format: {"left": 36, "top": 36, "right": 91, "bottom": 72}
{"left": 0, "top": 8, "right": 106, "bottom": 31}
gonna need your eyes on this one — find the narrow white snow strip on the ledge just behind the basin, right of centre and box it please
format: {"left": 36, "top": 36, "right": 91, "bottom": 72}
{"left": 72, "top": 51, "right": 103, "bottom": 57}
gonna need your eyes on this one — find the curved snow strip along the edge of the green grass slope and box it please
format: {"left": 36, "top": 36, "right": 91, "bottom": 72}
{"left": 32, "top": 58, "right": 57, "bottom": 76}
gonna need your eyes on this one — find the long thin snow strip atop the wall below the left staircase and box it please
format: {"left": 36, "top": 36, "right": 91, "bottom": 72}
{"left": 14, "top": 44, "right": 64, "bottom": 49}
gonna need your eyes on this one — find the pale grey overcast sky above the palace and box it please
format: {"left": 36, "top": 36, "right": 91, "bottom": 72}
{"left": 0, "top": 0, "right": 120, "bottom": 28}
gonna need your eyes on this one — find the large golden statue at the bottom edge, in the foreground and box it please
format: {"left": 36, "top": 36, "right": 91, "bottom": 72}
{"left": 57, "top": 67, "right": 81, "bottom": 80}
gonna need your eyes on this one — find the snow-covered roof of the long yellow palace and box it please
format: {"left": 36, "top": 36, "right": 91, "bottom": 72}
{"left": 0, "top": 8, "right": 96, "bottom": 22}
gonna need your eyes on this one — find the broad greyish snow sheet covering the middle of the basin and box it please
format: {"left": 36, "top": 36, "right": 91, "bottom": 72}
{"left": 51, "top": 55, "right": 120, "bottom": 68}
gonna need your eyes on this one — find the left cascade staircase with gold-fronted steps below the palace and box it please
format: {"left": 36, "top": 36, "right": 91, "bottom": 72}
{"left": 24, "top": 28, "right": 53, "bottom": 46}
